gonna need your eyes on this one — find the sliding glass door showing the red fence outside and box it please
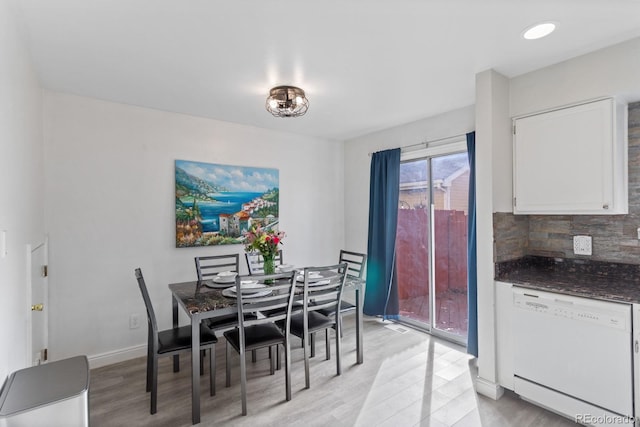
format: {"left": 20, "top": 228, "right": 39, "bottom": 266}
{"left": 396, "top": 152, "right": 469, "bottom": 343}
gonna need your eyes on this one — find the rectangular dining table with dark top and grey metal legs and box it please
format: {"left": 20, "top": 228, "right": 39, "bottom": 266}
{"left": 169, "top": 270, "right": 365, "bottom": 424}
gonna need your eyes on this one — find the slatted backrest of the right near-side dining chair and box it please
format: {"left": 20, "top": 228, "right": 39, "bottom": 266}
{"left": 303, "top": 262, "right": 347, "bottom": 322}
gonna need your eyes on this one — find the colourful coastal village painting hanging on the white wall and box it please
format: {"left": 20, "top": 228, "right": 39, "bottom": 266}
{"left": 175, "top": 160, "right": 280, "bottom": 248}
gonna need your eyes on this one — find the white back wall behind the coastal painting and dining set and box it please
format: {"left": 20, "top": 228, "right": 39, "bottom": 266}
{"left": 44, "top": 92, "right": 344, "bottom": 366}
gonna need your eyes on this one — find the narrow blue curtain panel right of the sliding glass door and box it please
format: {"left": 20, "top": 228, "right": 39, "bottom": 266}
{"left": 467, "top": 132, "right": 478, "bottom": 357}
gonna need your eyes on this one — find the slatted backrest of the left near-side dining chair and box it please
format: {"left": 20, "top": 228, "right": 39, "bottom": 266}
{"left": 236, "top": 271, "right": 296, "bottom": 348}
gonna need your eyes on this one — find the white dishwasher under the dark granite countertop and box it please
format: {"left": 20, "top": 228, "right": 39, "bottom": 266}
{"left": 513, "top": 287, "right": 634, "bottom": 425}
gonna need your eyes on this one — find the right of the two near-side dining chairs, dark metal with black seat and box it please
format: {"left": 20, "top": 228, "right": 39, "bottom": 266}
{"left": 291, "top": 262, "right": 347, "bottom": 388}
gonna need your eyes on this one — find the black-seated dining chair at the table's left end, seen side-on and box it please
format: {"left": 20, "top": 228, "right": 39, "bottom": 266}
{"left": 135, "top": 268, "right": 218, "bottom": 414}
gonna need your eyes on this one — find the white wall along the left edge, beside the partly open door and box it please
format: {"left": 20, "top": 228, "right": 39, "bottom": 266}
{"left": 0, "top": 0, "right": 44, "bottom": 383}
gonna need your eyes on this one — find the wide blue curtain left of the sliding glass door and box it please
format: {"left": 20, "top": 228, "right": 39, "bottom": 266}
{"left": 364, "top": 148, "right": 400, "bottom": 319}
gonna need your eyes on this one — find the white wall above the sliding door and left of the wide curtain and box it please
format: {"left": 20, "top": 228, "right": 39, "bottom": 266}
{"left": 344, "top": 106, "right": 475, "bottom": 252}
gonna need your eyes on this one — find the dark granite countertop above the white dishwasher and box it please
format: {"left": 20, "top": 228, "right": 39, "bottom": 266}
{"left": 495, "top": 256, "right": 640, "bottom": 303}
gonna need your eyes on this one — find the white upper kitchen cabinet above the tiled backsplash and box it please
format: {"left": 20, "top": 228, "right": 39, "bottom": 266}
{"left": 513, "top": 98, "right": 628, "bottom": 214}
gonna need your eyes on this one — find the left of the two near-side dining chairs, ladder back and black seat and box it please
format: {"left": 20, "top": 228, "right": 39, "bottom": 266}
{"left": 224, "top": 271, "right": 296, "bottom": 415}
